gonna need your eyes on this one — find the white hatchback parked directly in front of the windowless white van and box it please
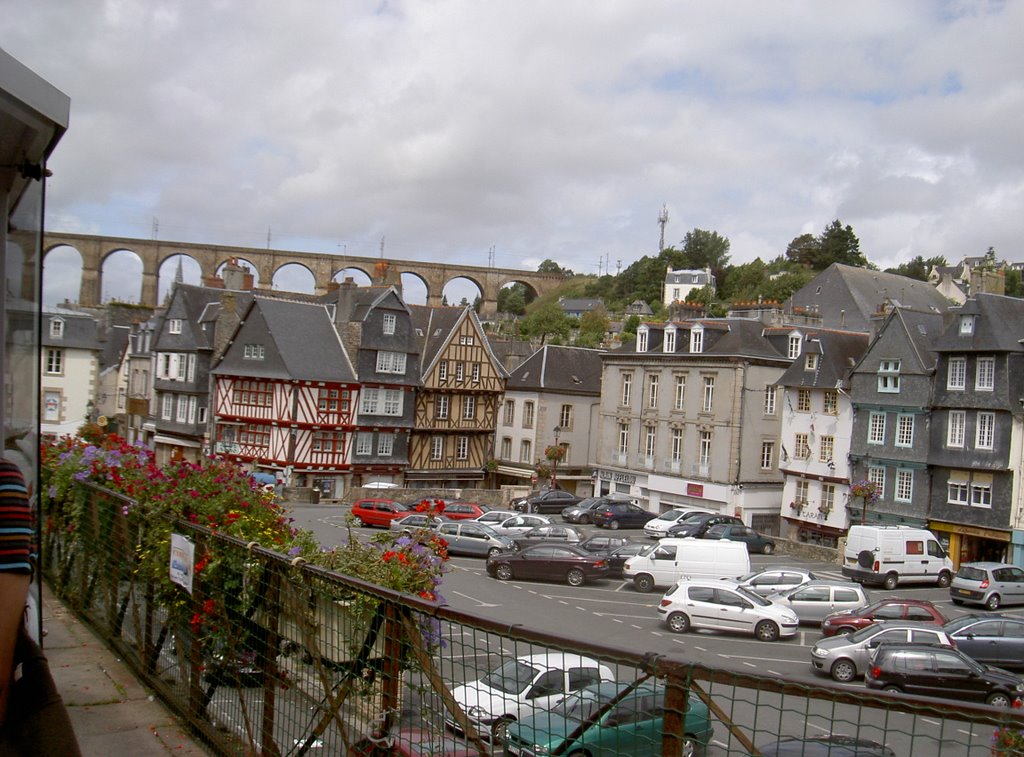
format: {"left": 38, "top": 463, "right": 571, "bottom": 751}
{"left": 657, "top": 579, "right": 800, "bottom": 641}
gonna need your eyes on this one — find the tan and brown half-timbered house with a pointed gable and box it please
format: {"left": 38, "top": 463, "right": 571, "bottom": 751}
{"left": 406, "top": 305, "right": 508, "bottom": 488}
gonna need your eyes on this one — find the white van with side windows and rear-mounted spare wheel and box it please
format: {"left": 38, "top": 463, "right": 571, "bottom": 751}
{"left": 843, "top": 525, "right": 953, "bottom": 589}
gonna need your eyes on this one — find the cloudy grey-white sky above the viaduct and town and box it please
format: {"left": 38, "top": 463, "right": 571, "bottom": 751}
{"left": 0, "top": 0, "right": 1024, "bottom": 307}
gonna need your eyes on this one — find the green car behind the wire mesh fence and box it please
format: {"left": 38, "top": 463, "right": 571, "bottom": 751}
{"left": 505, "top": 681, "right": 714, "bottom": 757}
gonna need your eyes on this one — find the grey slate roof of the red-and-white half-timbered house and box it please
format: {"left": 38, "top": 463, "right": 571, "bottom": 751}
{"left": 213, "top": 296, "right": 356, "bottom": 383}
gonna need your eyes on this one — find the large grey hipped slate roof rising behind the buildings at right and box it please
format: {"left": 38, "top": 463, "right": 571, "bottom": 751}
{"left": 783, "top": 263, "right": 949, "bottom": 332}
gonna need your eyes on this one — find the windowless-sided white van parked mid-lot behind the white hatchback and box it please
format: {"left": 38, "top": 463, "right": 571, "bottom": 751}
{"left": 623, "top": 538, "right": 751, "bottom": 592}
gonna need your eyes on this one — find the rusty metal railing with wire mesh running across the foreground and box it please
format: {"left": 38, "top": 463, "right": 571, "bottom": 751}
{"left": 42, "top": 487, "right": 1024, "bottom": 757}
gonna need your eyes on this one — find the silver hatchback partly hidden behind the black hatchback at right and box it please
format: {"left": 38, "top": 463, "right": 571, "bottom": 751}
{"left": 811, "top": 621, "right": 953, "bottom": 683}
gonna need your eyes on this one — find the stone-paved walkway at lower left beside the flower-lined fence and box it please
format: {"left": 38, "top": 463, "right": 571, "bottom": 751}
{"left": 43, "top": 583, "right": 211, "bottom": 757}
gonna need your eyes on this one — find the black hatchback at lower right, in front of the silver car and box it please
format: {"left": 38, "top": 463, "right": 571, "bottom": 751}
{"left": 864, "top": 644, "right": 1024, "bottom": 707}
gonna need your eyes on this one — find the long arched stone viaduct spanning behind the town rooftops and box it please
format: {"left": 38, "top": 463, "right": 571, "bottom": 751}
{"left": 43, "top": 232, "right": 563, "bottom": 318}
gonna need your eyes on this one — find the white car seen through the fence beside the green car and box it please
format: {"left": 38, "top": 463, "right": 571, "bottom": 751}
{"left": 445, "top": 651, "right": 615, "bottom": 744}
